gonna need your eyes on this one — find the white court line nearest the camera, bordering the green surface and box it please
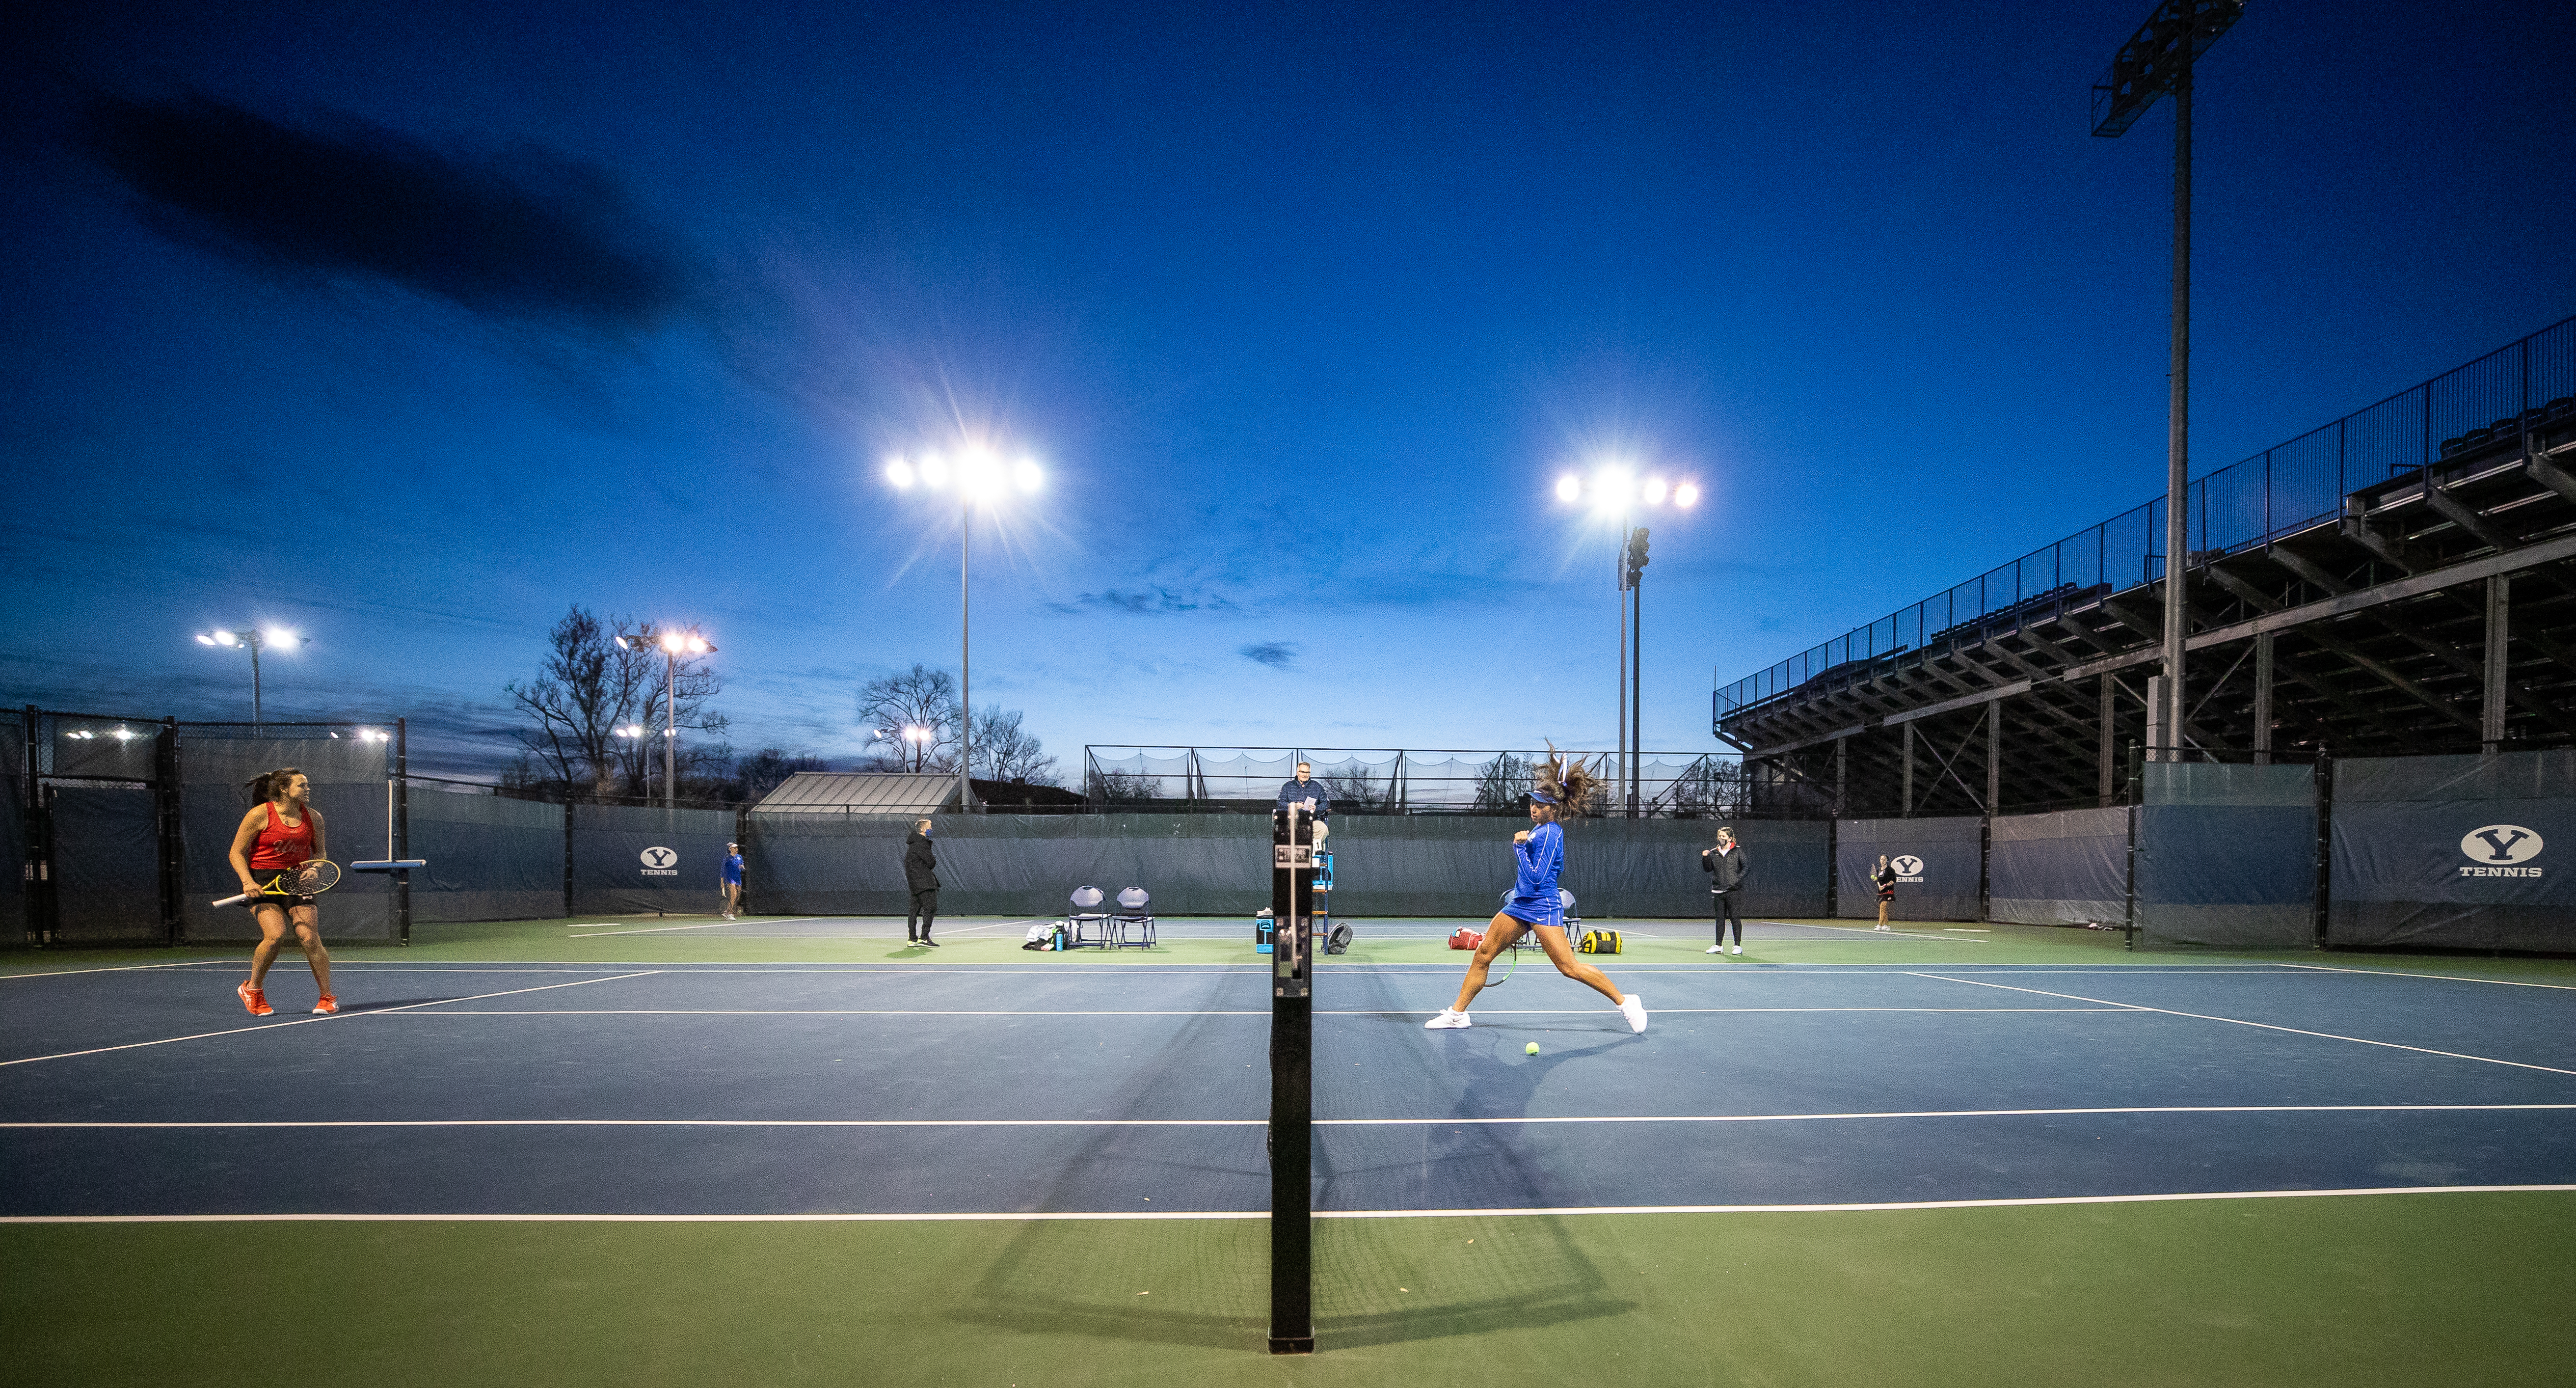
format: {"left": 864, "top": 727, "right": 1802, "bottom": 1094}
{"left": 0, "top": 1185, "right": 2576, "bottom": 1223}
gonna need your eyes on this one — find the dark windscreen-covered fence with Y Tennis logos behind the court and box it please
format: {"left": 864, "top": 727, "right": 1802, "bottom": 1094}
{"left": 0, "top": 708, "right": 2576, "bottom": 953}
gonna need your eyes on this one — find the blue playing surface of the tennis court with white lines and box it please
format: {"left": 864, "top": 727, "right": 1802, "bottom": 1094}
{"left": 0, "top": 958, "right": 2576, "bottom": 1218}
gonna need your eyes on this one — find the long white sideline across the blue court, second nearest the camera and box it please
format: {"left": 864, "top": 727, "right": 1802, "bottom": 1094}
{"left": 0, "top": 1102, "right": 2576, "bottom": 1130}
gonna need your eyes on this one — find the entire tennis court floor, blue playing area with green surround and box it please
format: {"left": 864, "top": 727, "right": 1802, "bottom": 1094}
{"left": 0, "top": 919, "right": 2576, "bottom": 1383}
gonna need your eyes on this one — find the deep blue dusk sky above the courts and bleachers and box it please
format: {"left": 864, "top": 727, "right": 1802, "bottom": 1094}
{"left": 0, "top": 0, "right": 2576, "bottom": 770}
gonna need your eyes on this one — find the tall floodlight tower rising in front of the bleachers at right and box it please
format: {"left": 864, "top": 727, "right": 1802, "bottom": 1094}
{"left": 2095, "top": 0, "right": 2246, "bottom": 759}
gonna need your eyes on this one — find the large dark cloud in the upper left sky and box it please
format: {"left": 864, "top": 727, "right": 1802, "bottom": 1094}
{"left": 83, "top": 95, "right": 690, "bottom": 335}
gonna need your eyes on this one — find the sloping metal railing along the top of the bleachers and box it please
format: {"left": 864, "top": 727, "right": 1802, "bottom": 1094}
{"left": 1713, "top": 317, "right": 2576, "bottom": 719}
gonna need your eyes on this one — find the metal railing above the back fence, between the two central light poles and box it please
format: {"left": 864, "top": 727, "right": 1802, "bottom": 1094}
{"left": 1082, "top": 747, "right": 1754, "bottom": 819}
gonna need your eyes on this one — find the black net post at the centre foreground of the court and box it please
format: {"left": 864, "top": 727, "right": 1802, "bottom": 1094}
{"left": 1270, "top": 806, "right": 1314, "bottom": 1354}
